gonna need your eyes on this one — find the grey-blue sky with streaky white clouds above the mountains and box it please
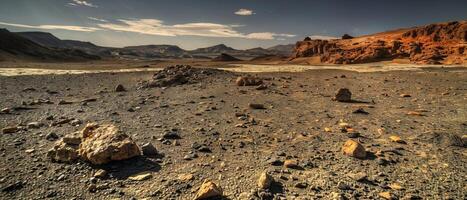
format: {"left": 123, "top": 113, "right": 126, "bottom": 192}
{"left": 0, "top": 0, "right": 467, "bottom": 50}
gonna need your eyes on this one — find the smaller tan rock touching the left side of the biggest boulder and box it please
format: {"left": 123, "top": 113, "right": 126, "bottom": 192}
{"left": 47, "top": 139, "right": 79, "bottom": 163}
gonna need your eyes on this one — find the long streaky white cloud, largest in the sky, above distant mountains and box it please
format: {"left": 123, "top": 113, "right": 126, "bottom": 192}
{"left": 97, "top": 19, "right": 295, "bottom": 40}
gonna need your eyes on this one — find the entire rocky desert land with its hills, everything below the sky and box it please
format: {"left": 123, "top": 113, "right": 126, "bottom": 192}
{"left": 0, "top": 1, "right": 467, "bottom": 200}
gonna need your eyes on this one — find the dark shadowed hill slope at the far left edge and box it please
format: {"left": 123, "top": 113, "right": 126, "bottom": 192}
{"left": 0, "top": 29, "right": 100, "bottom": 61}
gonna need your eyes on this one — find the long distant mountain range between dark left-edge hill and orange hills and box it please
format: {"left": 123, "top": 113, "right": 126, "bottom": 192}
{"left": 2, "top": 29, "right": 295, "bottom": 59}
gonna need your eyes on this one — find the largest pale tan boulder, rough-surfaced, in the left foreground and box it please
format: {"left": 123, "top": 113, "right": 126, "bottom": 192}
{"left": 79, "top": 123, "right": 141, "bottom": 165}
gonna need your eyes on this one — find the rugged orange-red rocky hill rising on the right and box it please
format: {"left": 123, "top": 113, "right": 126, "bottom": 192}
{"left": 291, "top": 21, "right": 467, "bottom": 64}
